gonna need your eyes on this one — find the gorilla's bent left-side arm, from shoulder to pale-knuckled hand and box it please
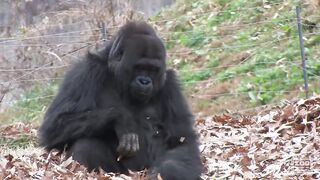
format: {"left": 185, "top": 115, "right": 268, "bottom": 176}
{"left": 39, "top": 52, "right": 139, "bottom": 154}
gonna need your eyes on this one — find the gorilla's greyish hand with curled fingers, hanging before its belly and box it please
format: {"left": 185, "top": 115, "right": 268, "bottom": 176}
{"left": 117, "top": 133, "right": 139, "bottom": 158}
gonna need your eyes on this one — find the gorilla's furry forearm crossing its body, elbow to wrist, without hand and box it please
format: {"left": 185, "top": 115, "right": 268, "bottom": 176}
{"left": 40, "top": 108, "right": 129, "bottom": 150}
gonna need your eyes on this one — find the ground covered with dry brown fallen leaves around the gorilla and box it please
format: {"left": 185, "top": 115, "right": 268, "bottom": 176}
{"left": 0, "top": 96, "right": 320, "bottom": 180}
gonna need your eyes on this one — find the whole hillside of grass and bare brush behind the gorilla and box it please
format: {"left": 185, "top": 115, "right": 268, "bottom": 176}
{"left": 0, "top": 0, "right": 320, "bottom": 123}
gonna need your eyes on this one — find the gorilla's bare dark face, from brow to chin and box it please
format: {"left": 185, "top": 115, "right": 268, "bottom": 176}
{"left": 124, "top": 36, "right": 165, "bottom": 102}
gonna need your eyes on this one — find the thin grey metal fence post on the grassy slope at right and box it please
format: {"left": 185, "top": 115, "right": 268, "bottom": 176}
{"left": 296, "top": 6, "right": 309, "bottom": 98}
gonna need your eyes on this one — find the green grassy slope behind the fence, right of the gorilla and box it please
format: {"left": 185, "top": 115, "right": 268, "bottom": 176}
{"left": 152, "top": 0, "right": 320, "bottom": 108}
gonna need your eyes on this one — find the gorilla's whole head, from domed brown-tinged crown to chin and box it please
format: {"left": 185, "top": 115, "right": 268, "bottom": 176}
{"left": 108, "top": 22, "right": 166, "bottom": 103}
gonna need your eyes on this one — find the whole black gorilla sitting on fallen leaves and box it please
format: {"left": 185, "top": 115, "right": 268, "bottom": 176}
{"left": 39, "top": 22, "right": 202, "bottom": 180}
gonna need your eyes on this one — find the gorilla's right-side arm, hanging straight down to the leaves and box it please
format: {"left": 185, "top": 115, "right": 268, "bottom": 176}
{"left": 150, "top": 70, "right": 202, "bottom": 179}
